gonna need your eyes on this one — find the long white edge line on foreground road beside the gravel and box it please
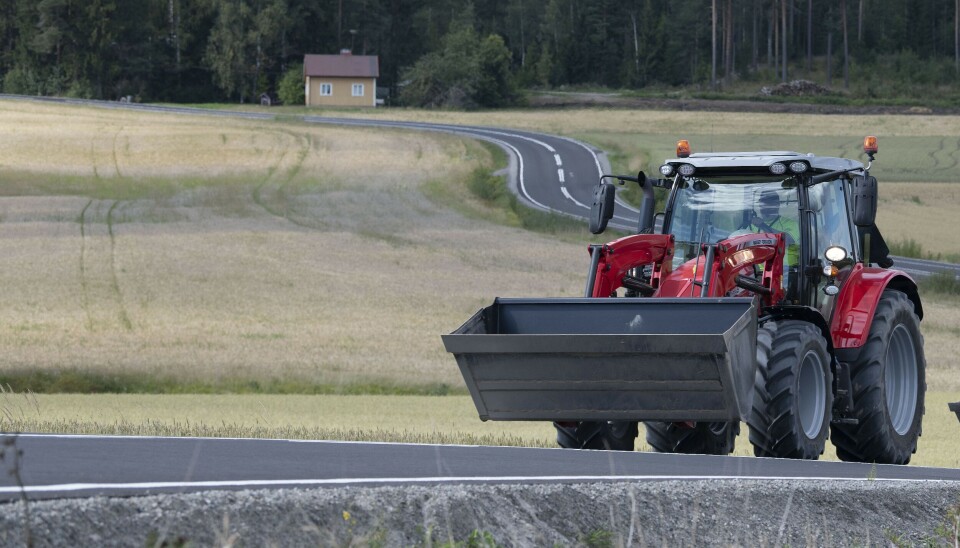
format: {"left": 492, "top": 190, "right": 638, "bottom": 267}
{"left": 0, "top": 475, "right": 957, "bottom": 494}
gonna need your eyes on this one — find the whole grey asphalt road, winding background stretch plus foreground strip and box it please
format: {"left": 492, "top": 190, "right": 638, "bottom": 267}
{"left": 0, "top": 96, "right": 960, "bottom": 500}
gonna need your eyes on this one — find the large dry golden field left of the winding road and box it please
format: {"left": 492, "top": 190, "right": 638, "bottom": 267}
{"left": 0, "top": 98, "right": 583, "bottom": 390}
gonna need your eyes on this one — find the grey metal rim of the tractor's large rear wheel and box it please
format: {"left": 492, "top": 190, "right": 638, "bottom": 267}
{"left": 883, "top": 324, "right": 918, "bottom": 436}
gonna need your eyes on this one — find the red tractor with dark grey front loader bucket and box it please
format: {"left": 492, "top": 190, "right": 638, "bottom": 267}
{"left": 443, "top": 137, "right": 926, "bottom": 464}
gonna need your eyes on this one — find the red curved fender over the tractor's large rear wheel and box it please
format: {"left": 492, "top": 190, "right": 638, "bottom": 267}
{"left": 830, "top": 263, "right": 923, "bottom": 354}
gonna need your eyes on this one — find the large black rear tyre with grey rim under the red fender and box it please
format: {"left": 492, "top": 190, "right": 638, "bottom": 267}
{"left": 830, "top": 290, "right": 927, "bottom": 464}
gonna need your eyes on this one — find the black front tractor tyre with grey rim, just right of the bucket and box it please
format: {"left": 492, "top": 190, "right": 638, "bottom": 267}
{"left": 748, "top": 320, "right": 833, "bottom": 459}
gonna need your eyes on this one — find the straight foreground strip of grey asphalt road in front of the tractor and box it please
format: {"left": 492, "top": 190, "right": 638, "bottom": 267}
{"left": 0, "top": 434, "right": 960, "bottom": 501}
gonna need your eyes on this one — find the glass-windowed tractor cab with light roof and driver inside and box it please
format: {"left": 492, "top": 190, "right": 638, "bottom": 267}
{"left": 660, "top": 151, "right": 864, "bottom": 318}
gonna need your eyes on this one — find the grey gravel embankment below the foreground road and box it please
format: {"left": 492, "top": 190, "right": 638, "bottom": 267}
{"left": 0, "top": 480, "right": 960, "bottom": 546}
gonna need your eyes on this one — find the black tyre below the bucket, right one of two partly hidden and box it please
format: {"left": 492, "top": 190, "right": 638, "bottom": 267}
{"left": 644, "top": 421, "right": 740, "bottom": 455}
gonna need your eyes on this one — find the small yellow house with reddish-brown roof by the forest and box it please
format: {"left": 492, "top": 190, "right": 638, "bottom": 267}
{"left": 303, "top": 50, "right": 380, "bottom": 107}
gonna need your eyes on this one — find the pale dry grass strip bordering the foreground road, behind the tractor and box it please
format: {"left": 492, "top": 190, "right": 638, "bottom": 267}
{"left": 0, "top": 391, "right": 960, "bottom": 468}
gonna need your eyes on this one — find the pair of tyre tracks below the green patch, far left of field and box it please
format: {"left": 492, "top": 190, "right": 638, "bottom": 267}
{"left": 78, "top": 198, "right": 133, "bottom": 331}
